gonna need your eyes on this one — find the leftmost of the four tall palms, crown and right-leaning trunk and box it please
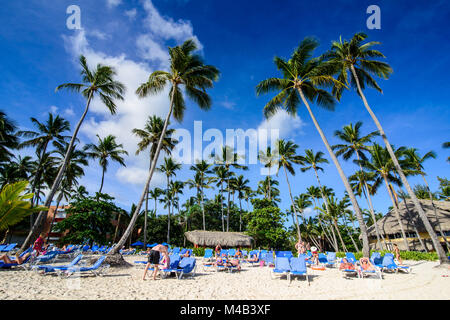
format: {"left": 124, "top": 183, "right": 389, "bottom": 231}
{"left": 20, "top": 56, "right": 125, "bottom": 251}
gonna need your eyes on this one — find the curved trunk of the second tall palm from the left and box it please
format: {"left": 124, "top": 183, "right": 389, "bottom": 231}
{"left": 109, "top": 88, "right": 175, "bottom": 255}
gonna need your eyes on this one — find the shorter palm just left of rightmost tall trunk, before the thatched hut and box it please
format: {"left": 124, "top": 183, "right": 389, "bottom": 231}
{"left": 360, "top": 143, "right": 409, "bottom": 250}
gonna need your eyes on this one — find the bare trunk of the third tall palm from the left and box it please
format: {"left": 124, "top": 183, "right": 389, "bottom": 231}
{"left": 298, "top": 88, "right": 370, "bottom": 257}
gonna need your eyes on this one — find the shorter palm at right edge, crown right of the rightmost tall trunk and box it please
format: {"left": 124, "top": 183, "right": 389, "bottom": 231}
{"left": 403, "top": 148, "right": 450, "bottom": 251}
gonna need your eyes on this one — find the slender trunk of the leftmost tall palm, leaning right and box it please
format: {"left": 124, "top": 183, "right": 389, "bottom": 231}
{"left": 19, "top": 92, "right": 92, "bottom": 252}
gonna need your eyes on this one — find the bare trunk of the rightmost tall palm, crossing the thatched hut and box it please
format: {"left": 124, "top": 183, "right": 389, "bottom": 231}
{"left": 351, "top": 65, "right": 449, "bottom": 264}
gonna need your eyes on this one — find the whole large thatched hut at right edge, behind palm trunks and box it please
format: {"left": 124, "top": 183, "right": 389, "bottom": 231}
{"left": 367, "top": 200, "right": 450, "bottom": 251}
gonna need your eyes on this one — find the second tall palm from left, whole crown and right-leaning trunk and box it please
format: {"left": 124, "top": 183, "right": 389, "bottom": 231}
{"left": 110, "top": 40, "right": 219, "bottom": 254}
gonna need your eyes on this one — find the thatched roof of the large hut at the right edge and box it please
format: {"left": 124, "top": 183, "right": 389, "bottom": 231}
{"left": 367, "top": 199, "right": 450, "bottom": 236}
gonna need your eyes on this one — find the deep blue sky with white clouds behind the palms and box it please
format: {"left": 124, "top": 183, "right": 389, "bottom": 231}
{"left": 0, "top": 0, "right": 450, "bottom": 225}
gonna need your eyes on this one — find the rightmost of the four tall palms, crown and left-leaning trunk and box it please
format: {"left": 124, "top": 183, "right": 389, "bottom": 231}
{"left": 326, "top": 33, "right": 448, "bottom": 264}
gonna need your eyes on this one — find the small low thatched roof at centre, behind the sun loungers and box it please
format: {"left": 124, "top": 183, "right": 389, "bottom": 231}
{"left": 184, "top": 230, "right": 253, "bottom": 247}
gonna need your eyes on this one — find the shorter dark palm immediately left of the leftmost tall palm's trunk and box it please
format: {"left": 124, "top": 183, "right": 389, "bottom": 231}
{"left": 17, "top": 112, "right": 70, "bottom": 205}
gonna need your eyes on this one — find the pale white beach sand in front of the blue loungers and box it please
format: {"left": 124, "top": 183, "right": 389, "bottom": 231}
{"left": 0, "top": 256, "right": 450, "bottom": 300}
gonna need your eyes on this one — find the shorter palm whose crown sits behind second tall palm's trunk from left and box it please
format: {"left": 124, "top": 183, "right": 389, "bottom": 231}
{"left": 132, "top": 115, "right": 178, "bottom": 248}
